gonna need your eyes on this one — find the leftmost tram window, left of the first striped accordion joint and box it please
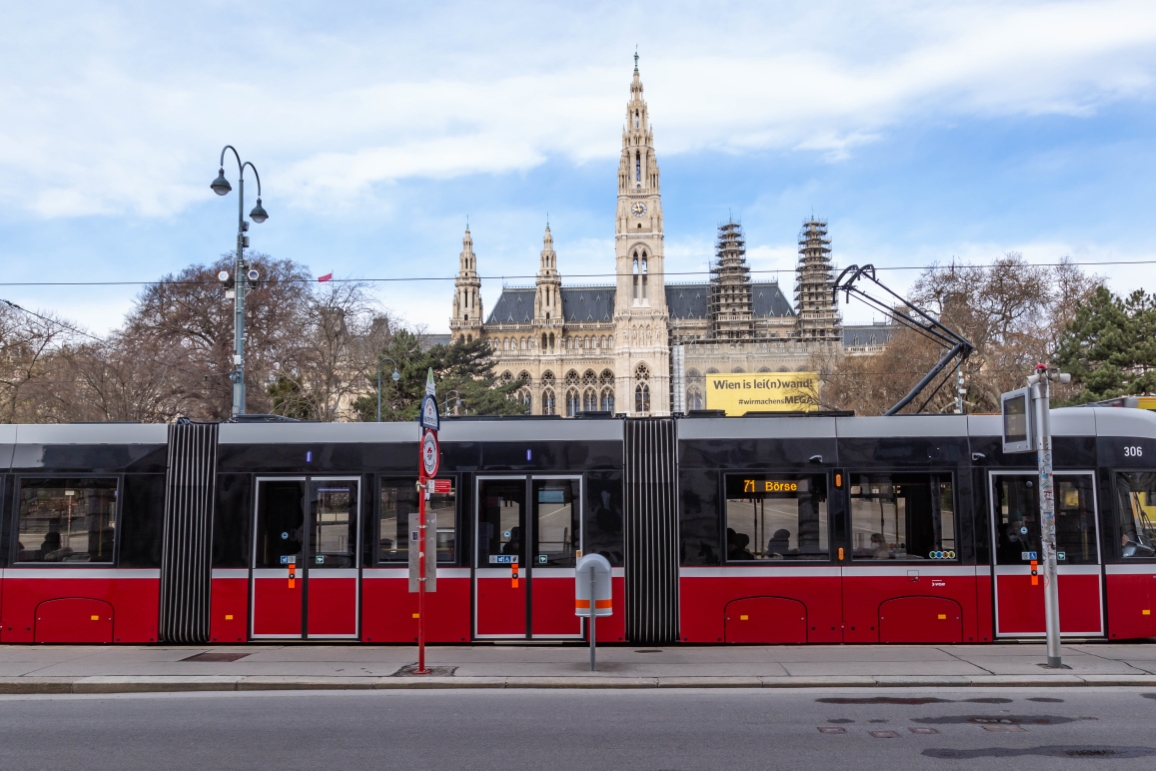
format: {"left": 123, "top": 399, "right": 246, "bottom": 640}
{"left": 16, "top": 477, "right": 117, "bottom": 563}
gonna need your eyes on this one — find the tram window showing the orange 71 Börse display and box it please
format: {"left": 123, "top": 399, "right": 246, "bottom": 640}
{"left": 726, "top": 474, "right": 831, "bottom": 562}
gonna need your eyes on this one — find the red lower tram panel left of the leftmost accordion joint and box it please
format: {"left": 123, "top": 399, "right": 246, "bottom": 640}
{"left": 0, "top": 568, "right": 161, "bottom": 643}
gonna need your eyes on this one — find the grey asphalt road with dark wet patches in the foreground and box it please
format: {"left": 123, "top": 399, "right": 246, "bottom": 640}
{"left": 0, "top": 688, "right": 1156, "bottom": 771}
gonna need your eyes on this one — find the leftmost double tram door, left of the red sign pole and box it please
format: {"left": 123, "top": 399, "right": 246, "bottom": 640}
{"left": 251, "top": 476, "right": 360, "bottom": 638}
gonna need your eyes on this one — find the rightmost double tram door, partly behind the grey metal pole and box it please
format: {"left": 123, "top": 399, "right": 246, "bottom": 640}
{"left": 991, "top": 473, "right": 1104, "bottom": 637}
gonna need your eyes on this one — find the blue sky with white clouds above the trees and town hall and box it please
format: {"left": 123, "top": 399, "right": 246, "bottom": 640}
{"left": 0, "top": 0, "right": 1156, "bottom": 332}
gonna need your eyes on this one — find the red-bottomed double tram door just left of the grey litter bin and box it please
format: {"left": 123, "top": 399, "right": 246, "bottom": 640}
{"left": 474, "top": 476, "right": 583, "bottom": 639}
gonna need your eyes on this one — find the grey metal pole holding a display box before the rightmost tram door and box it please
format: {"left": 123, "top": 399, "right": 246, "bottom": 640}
{"left": 1028, "top": 364, "right": 1072, "bottom": 669}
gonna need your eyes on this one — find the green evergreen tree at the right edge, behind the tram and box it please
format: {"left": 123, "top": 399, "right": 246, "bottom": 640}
{"left": 1055, "top": 287, "right": 1156, "bottom": 403}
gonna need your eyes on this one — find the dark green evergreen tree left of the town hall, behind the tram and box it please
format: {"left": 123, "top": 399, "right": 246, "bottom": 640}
{"left": 354, "top": 331, "right": 528, "bottom": 421}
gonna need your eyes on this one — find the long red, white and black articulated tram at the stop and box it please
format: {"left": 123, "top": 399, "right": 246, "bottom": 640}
{"left": 0, "top": 408, "right": 1156, "bottom": 644}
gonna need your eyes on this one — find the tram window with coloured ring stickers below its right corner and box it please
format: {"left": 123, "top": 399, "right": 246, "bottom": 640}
{"left": 851, "top": 474, "right": 957, "bottom": 561}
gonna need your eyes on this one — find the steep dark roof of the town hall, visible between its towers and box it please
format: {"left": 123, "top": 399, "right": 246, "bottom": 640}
{"left": 486, "top": 281, "right": 794, "bottom": 324}
